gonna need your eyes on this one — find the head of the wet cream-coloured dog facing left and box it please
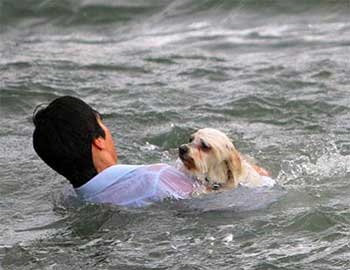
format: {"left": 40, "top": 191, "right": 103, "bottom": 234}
{"left": 179, "top": 128, "right": 242, "bottom": 189}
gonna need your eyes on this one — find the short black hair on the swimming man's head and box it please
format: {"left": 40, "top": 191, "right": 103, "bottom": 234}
{"left": 33, "top": 96, "right": 105, "bottom": 187}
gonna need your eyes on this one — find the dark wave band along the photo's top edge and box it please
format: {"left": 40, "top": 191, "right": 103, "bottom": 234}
{"left": 0, "top": 0, "right": 349, "bottom": 26}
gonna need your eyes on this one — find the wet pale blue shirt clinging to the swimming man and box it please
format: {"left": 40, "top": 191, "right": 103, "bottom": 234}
{"left": 75, "top": 164, "right": 197, "bottom": 207}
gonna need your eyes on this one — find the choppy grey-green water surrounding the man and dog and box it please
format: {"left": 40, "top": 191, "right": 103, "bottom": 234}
{"left": 0, "top": 0, "right": 350, "bottom": 270}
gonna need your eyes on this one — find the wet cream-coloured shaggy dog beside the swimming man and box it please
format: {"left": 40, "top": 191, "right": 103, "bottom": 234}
{"left": 179, "top": 128, "right": 274, "bottom": 192}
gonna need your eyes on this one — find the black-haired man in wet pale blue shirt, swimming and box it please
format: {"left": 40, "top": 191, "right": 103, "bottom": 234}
{"left": 33, "top": 96, "right": 197, "bottom": 206}
